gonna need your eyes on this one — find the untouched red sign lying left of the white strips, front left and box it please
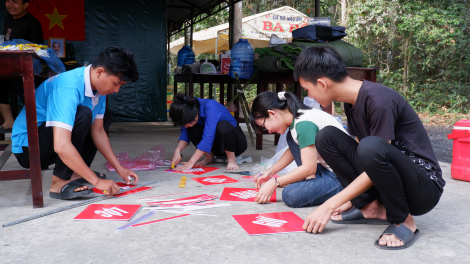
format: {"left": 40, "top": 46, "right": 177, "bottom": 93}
{"left": 73, "top": 204, "right": 141, "bottom": 221}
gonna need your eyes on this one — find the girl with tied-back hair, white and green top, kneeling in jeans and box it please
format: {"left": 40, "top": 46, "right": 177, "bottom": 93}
{"left": 250, "top": 92, "right": 347, "bottom": 207}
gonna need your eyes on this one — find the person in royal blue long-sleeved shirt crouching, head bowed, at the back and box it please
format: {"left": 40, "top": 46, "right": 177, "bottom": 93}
{"left": 169, "top": 94, "right": 247, "bottom": 171}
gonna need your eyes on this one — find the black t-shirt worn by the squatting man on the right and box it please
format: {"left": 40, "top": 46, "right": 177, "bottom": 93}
{"left": 344, "top": 81, "right": 446, "bottom": 190}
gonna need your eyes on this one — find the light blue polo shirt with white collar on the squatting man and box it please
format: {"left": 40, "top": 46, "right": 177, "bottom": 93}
{"left": 11, "top": 65, "right": 106, "bottom": 153}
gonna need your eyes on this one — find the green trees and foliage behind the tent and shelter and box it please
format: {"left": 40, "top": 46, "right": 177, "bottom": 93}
{"left": 172, "top": 0, "right": 470, "bottom": 113}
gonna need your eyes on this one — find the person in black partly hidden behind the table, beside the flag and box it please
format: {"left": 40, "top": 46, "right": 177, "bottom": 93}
{"left": 0, "top": 0, "right": 44, "bottom": 133}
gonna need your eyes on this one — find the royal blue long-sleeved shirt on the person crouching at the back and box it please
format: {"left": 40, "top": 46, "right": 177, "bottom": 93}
{"left": 178, "top": 98, "right": 237, "bottom": 153}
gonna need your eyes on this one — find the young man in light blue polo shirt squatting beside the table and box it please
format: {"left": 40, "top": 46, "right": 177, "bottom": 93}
{"left": 12, "top": 47, "right": 139, "bottom": 199}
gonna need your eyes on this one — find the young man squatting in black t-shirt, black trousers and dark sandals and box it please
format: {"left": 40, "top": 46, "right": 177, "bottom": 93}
{"left": 294, "top": 46, "right": 445, "bottom": 249}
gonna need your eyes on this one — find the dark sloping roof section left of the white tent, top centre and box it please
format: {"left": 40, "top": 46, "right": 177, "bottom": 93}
{"left": 166, "top": 0, "right": 242, "bottom": 35}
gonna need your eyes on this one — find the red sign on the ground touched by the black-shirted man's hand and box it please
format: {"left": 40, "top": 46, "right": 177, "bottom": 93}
{"left": 232, "top": 212, "right": 304, "bottom": 236}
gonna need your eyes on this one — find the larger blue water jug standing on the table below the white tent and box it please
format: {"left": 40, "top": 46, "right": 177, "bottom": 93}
{"left": 229, "top": 39, "right": 255, "bottom": 79}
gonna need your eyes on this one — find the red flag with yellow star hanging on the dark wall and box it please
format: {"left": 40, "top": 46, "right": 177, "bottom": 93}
{"left": 28, "top": 0, "right": 85, "bottom": 41}
